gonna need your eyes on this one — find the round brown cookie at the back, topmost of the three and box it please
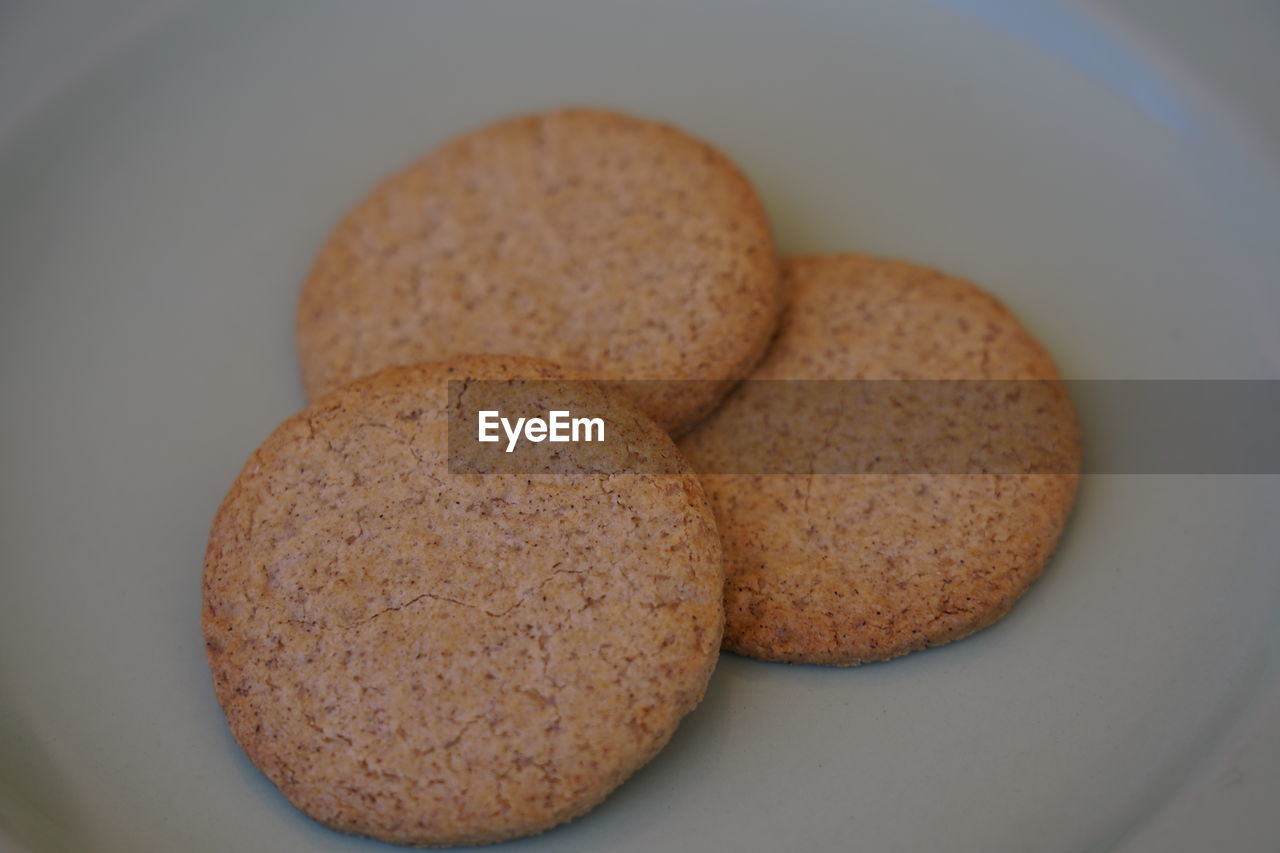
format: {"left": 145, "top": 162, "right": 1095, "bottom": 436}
{"left": 297, "top": 109, "right": 778, "bottom": 434}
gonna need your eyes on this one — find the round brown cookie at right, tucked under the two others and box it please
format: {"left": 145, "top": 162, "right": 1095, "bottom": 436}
{"left": 681, "top": 255, "right": 1080, "bottom": 665}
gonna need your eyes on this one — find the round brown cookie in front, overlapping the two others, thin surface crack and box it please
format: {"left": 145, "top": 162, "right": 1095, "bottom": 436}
{"left": 201, "top": 356, "right": 723, "bottom": 845}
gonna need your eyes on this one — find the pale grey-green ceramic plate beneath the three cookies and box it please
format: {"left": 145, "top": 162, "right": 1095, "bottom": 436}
{"left": 0, "top": 0, "right": 1280, "bottom": 853}
